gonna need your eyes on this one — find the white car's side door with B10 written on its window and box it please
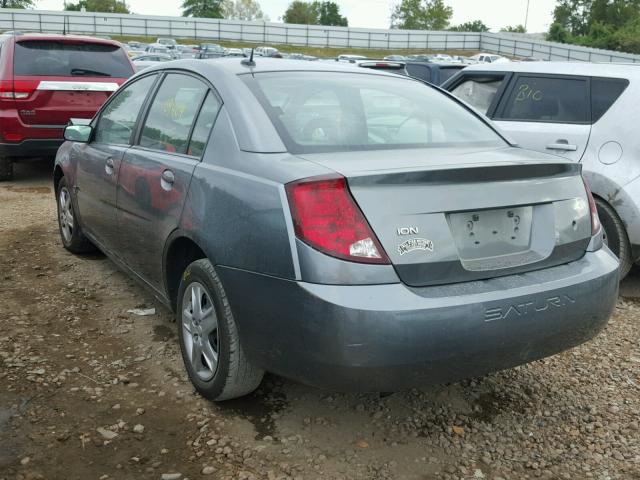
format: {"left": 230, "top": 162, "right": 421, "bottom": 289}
{"left": 493, "top": 74, "right": 591, "bottom": 161}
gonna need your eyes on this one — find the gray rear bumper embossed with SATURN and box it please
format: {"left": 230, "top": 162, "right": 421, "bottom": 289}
{"left": 219, "top": 248, "right": 618, "bottom": 391}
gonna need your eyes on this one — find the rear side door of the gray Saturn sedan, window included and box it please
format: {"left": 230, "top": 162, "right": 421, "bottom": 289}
{"left": 117, "top": 72, "right": 221, "bottom": 290}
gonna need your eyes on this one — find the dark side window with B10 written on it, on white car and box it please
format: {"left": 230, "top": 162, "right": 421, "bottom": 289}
{"left": 500, "top": 76, "right": 590, "bottom": 123}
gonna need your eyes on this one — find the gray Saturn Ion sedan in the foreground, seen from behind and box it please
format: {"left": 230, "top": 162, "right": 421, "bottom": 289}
{"left": 54, "top": 57, "right": 618, "bottom": 400}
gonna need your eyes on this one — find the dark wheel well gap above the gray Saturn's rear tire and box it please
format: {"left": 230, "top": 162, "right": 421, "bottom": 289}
{"left": 163, "top": 230, "right": 208, "bottom": 310}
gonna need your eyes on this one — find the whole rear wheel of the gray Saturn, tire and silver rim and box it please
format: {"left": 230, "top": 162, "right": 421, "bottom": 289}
{"left": 177, "top": 259, "right": 264, "bottom": 401}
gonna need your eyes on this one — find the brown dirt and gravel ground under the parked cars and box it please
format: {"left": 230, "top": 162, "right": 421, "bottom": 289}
{"left": 0, "top": 163, "right": 640, "bottom": 480}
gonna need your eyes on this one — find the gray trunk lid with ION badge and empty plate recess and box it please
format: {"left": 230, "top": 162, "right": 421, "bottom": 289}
{"left": 304, "top": 148, "right": 591, "bottom": 287}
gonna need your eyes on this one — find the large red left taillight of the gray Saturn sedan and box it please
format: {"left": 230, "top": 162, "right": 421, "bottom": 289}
{"left": 286, "top": 177, "right": 390, "bottom": 264}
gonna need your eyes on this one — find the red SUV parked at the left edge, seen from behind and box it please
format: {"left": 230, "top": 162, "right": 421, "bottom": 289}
{"left": 0, "top": 33, "right": 134, "bottom": 180}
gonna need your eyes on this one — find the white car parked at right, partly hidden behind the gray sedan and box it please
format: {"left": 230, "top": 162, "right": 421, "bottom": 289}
{"left": 443, "top": 62, "right": 640, "bottom": 278}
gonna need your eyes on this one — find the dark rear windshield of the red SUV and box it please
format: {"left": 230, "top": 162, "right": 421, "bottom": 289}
{"left": 13, "top": 40, "right": 133, "bottom": 78}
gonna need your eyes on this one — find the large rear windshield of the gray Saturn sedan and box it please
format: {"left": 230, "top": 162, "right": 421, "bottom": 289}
{"left": 242, "top": 72, "right": 505, "bottom": 153}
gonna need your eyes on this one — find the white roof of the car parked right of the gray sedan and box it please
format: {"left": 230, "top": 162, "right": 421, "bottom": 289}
{"left": 465, "top": 62, "right": 640, "bottom": 77}
